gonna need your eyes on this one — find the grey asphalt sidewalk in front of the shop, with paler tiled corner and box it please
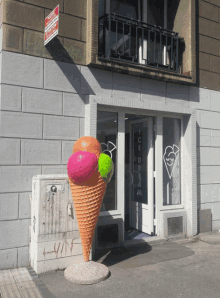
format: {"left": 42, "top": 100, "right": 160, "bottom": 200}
{"left": 0, "top": 231, "right": 220, "bottom": 298}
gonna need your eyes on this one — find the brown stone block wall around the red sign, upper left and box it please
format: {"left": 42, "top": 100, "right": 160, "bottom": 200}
{"left": 0, "top": 0, "right": 87, "bottom": 64}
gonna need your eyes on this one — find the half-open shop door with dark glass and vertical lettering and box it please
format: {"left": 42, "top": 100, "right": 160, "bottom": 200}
{"left": 125, "top": 115, "right": 155, "bottom": 235}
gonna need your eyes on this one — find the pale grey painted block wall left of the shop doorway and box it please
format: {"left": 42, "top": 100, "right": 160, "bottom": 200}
{"left": 0, "top": 51, "right": 85, "bottom": 269}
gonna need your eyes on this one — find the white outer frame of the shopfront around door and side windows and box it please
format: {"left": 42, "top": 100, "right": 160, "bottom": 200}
{"left": 95, "top": 105, "right": 187, "bottom": 242}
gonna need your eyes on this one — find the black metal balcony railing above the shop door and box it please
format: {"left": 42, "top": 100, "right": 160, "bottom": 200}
{"left": 99, "top": 13, "right": 184, "bottom": 73}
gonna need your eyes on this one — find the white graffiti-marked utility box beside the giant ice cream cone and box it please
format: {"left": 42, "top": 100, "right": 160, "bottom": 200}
{"left": 30, "top": 175, "right": 86, "bottom": 274}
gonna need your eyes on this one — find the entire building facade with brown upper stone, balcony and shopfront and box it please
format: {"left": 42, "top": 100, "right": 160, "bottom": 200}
{"left": 0, "top": 0, "right": 220, "bottom": 269}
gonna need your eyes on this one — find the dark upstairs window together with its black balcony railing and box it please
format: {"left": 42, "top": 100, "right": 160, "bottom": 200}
{"left": 99, "top": 0, "right": 183, "bottom": 72}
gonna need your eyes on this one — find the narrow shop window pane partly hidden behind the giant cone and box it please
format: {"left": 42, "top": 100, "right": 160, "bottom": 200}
{"left": 97, "top": 111, "right": 118, "bottom": 211}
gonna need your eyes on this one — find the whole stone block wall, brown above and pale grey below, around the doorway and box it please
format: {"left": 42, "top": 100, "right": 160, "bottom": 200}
{"left": 0, "top": 0, "right": 220, "bottom": 269}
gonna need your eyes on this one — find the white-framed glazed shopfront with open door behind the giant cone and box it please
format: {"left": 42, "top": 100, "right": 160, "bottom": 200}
{"left": 97, "top": 106, "right": 185, "bottom": 249}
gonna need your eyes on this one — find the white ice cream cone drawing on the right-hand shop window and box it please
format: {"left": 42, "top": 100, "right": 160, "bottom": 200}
{"left": 163, "top": 145, "right": 180, "bottom": 179}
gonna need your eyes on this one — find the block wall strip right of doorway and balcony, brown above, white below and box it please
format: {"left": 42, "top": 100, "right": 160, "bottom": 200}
{"left": 196, "top": 0, "right": 220, "bottom": 230}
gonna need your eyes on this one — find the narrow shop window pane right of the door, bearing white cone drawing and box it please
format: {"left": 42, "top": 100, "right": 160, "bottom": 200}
{"left": 163, "top": 118, "right": 181, "bottom": 205}
